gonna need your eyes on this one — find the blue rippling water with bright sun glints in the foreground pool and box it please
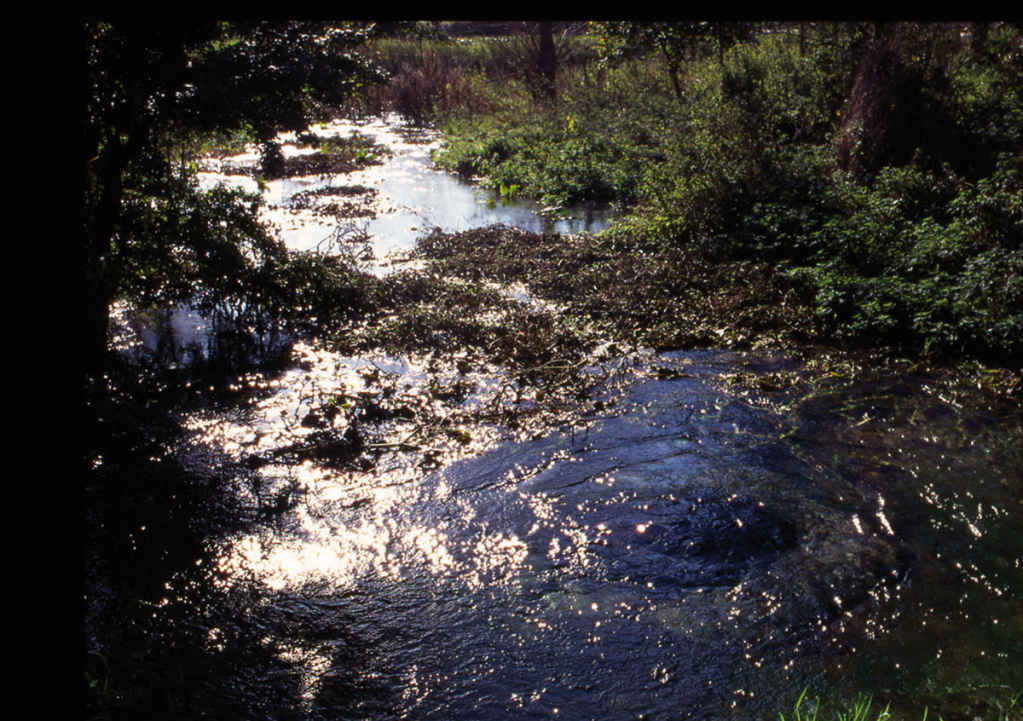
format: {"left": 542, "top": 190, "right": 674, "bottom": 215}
{"left": 195, "top": 347, "right": 1013, "bottom": 719}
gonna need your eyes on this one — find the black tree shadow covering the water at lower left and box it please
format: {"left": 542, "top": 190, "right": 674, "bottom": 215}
{"left": 79, "top": 313, "right": 372, "bottom": 721}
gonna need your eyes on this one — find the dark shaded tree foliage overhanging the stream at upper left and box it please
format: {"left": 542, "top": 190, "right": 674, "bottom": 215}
{"left": 79, "top": 19, "right": 384, "bottom": 380}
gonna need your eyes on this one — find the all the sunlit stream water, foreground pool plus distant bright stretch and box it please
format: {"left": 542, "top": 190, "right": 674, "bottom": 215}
{"left": 123, "top": 115, "right": 1023, "bottom": 721}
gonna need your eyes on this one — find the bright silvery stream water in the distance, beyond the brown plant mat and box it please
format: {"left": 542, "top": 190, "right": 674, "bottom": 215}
{"left": 121, "top": 118, "right": 611, "bottom": 364}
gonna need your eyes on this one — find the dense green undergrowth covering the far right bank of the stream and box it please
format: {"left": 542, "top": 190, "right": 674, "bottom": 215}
{"left": 368, "top": 25, "right": 1023, "bottom": 368}
